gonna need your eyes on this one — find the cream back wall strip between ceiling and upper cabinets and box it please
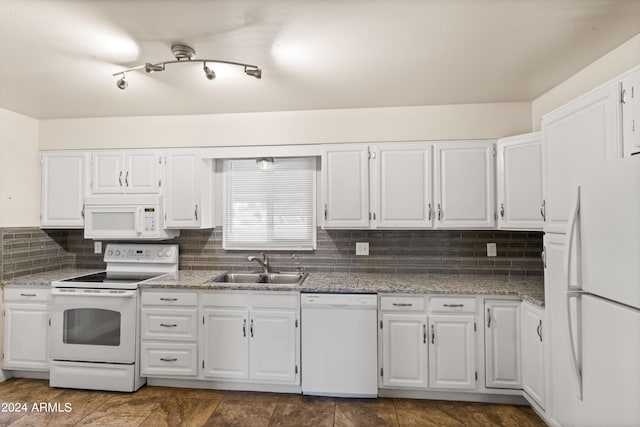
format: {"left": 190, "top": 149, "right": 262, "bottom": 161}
{"left": 40, "top": 102, "right": 531, "bottom": 150}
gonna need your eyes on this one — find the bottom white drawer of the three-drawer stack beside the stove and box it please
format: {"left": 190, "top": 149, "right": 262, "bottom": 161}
{"left": 140, "top": 343, "right": 198, "bottom": 376}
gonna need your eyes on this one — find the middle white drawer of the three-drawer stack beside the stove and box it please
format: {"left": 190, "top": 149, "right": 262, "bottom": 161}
{"left": 141, "top": 308, "right": 198, "bottom": 341}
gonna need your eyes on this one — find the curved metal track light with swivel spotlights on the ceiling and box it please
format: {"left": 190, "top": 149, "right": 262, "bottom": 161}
{"left": 113, "top": 44, "right": 262, "bottom": 90}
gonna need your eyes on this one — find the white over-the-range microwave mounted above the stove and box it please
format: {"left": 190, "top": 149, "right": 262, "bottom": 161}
{"left": 84, "top": 194, "right": 180, "bottom": 240}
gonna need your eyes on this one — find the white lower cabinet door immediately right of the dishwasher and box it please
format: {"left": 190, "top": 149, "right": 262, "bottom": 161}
{"left": 382, "top": 313, "right": 428, "bottom": 388}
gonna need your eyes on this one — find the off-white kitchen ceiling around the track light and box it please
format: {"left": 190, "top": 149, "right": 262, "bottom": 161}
{"left": 0, "top": 0, "right": 640, "bottom": 119}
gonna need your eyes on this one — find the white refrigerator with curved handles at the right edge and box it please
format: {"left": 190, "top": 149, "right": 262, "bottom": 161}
{"left": 551, "top": 156, "right": 640, "bottom": 427}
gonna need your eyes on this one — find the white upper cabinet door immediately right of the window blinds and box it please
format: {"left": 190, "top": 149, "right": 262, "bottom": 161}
{"left": 322, "top": 144, "right": 370, "bottom": 228}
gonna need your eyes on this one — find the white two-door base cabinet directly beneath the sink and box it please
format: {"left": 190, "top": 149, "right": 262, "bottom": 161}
{"left": 201, "top": 291, "right": 300, "bottom": 385}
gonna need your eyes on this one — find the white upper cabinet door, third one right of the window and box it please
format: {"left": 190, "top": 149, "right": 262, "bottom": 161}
{"left": 434, "top": 141, "right": 495, "bottom": 228}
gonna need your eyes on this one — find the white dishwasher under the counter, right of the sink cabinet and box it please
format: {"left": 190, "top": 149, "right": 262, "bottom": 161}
{"left": 300, "top": 293, "right": 378, "bottom": 397}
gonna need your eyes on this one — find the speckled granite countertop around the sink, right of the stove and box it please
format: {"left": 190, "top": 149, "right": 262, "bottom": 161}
{"left": 140, "top": 270, "right": 544, "bottom": 305}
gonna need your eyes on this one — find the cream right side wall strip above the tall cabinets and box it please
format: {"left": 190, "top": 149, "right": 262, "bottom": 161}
{"left": 531, "top": 34, "right": 640, "bottom": 131}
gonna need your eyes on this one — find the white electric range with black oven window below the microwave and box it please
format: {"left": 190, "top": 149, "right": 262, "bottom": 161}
{"left": 49, "top": 243, "right": 179, "bottom": 391}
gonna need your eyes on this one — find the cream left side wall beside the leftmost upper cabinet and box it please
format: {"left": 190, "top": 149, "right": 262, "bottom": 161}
{"left": 0, "top": 108, "right": 40, "bottom": 227}
